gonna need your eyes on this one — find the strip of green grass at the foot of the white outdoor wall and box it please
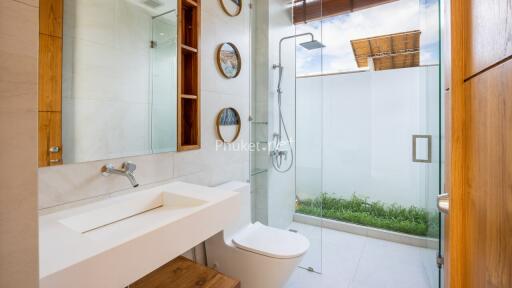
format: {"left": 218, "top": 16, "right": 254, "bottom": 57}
{"left": 296, "top": 193, "right": 439, "bottom": 237}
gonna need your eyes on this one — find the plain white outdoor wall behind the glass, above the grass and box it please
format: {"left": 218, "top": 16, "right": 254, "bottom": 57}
{"left": 297, "top": 66, "right": 439, "bottom": 207}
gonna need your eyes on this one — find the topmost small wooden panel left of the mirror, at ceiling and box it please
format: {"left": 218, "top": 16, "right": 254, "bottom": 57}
{"left": 39, "top": 0, "right": 64, "bottom": 37}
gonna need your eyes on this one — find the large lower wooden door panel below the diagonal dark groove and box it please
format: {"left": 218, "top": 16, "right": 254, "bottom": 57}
{"left": 464, "top": 60, "right": 512, "bottom": 288}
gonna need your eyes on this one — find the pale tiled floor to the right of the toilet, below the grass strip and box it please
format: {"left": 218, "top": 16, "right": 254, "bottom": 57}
{"left": 285, "top": 223, "right": 437, "bottom": 288}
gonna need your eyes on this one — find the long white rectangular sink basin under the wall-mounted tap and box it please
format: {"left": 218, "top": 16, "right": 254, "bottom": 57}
{"left": 39, "top": 182, "right": 240, "bottom": 288}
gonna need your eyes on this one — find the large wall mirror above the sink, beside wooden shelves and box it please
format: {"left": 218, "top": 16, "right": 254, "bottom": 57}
{"left": 55, "top": 0, "right": 178, "bottom": 164}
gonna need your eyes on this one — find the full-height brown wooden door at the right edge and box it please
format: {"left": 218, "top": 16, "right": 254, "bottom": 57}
{"left": 446, "top": 0, "right": 512, "bottom": 288}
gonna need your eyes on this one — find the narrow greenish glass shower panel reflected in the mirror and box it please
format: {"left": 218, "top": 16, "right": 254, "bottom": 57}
{"left": 150, "top": 11, "right": 178, "bottom": 153}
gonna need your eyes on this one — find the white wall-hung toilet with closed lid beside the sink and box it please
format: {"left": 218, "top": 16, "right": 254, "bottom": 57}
{"left": 206, "top": 182, "right": 309, "bottom": 288}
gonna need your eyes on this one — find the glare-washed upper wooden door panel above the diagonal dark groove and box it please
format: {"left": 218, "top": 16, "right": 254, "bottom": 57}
{"left": 462, "top": 0, "right": 512, "bottom": 79}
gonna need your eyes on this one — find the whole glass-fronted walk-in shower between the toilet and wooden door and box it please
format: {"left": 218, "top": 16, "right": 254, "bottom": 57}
{"left": 251, "top": 0, "right": 443, "bottom": 288}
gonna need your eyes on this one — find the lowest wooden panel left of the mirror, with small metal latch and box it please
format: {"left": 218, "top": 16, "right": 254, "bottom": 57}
{"left": 39, "top": 112, "right": 62, "bottom": 167}
